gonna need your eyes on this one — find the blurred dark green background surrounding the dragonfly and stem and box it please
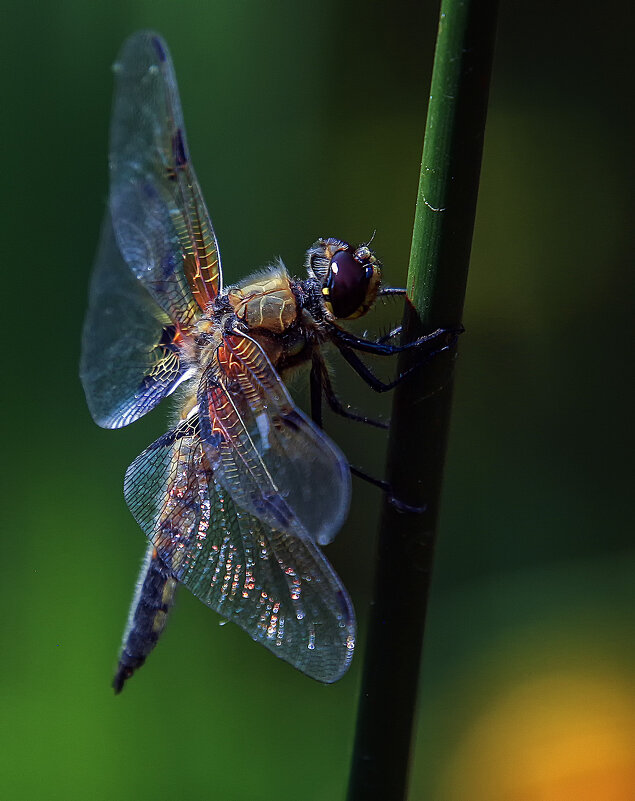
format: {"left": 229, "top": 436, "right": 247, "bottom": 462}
{"left": 0, "top": 0, "right": 635, "bottom": 801}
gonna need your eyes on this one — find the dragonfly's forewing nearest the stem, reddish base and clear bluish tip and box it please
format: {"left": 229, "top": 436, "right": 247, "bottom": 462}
{"left": 198, "top": 334, "right": 351, "bottom": 545}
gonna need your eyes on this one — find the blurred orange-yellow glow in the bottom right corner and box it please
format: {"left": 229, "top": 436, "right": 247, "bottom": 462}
{"left": 442, "top": 673, "right": 635, "bottom": 801}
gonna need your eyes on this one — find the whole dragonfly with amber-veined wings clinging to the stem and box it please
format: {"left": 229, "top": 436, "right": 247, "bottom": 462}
{"left": 80, "top": 31, "right": 458, "bottom": 692}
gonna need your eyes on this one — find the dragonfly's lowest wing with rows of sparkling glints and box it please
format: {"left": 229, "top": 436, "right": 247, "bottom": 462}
{"left": 124, "top": 415, "right": 355, "bottom": 683}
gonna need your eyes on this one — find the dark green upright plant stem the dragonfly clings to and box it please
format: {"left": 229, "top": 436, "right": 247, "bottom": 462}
{"left": 348, "top": 0, "right": 497, "bottom": 801}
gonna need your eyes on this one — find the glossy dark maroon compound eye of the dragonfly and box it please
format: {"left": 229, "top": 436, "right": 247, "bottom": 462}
{"left": 322, "top": 245, "right": 381, "bottom": 320}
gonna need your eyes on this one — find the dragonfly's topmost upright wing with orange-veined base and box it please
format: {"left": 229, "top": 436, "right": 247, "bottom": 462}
{"left": 110, "top": 31, "right": 221, "bottom": 330}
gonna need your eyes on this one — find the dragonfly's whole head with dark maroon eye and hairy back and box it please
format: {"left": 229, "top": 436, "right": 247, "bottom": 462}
{"left": 306, "top": 237, "right": 381, "bottom": 320}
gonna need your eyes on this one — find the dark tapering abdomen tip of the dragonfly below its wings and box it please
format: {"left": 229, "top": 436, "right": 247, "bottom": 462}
{"left": 112, "top": 545, "right": 178, "bottom": 693}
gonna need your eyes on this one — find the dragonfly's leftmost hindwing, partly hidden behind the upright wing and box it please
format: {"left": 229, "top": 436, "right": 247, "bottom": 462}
{"left": 80, "top": 212, "right": 189, "bottom": 428}
